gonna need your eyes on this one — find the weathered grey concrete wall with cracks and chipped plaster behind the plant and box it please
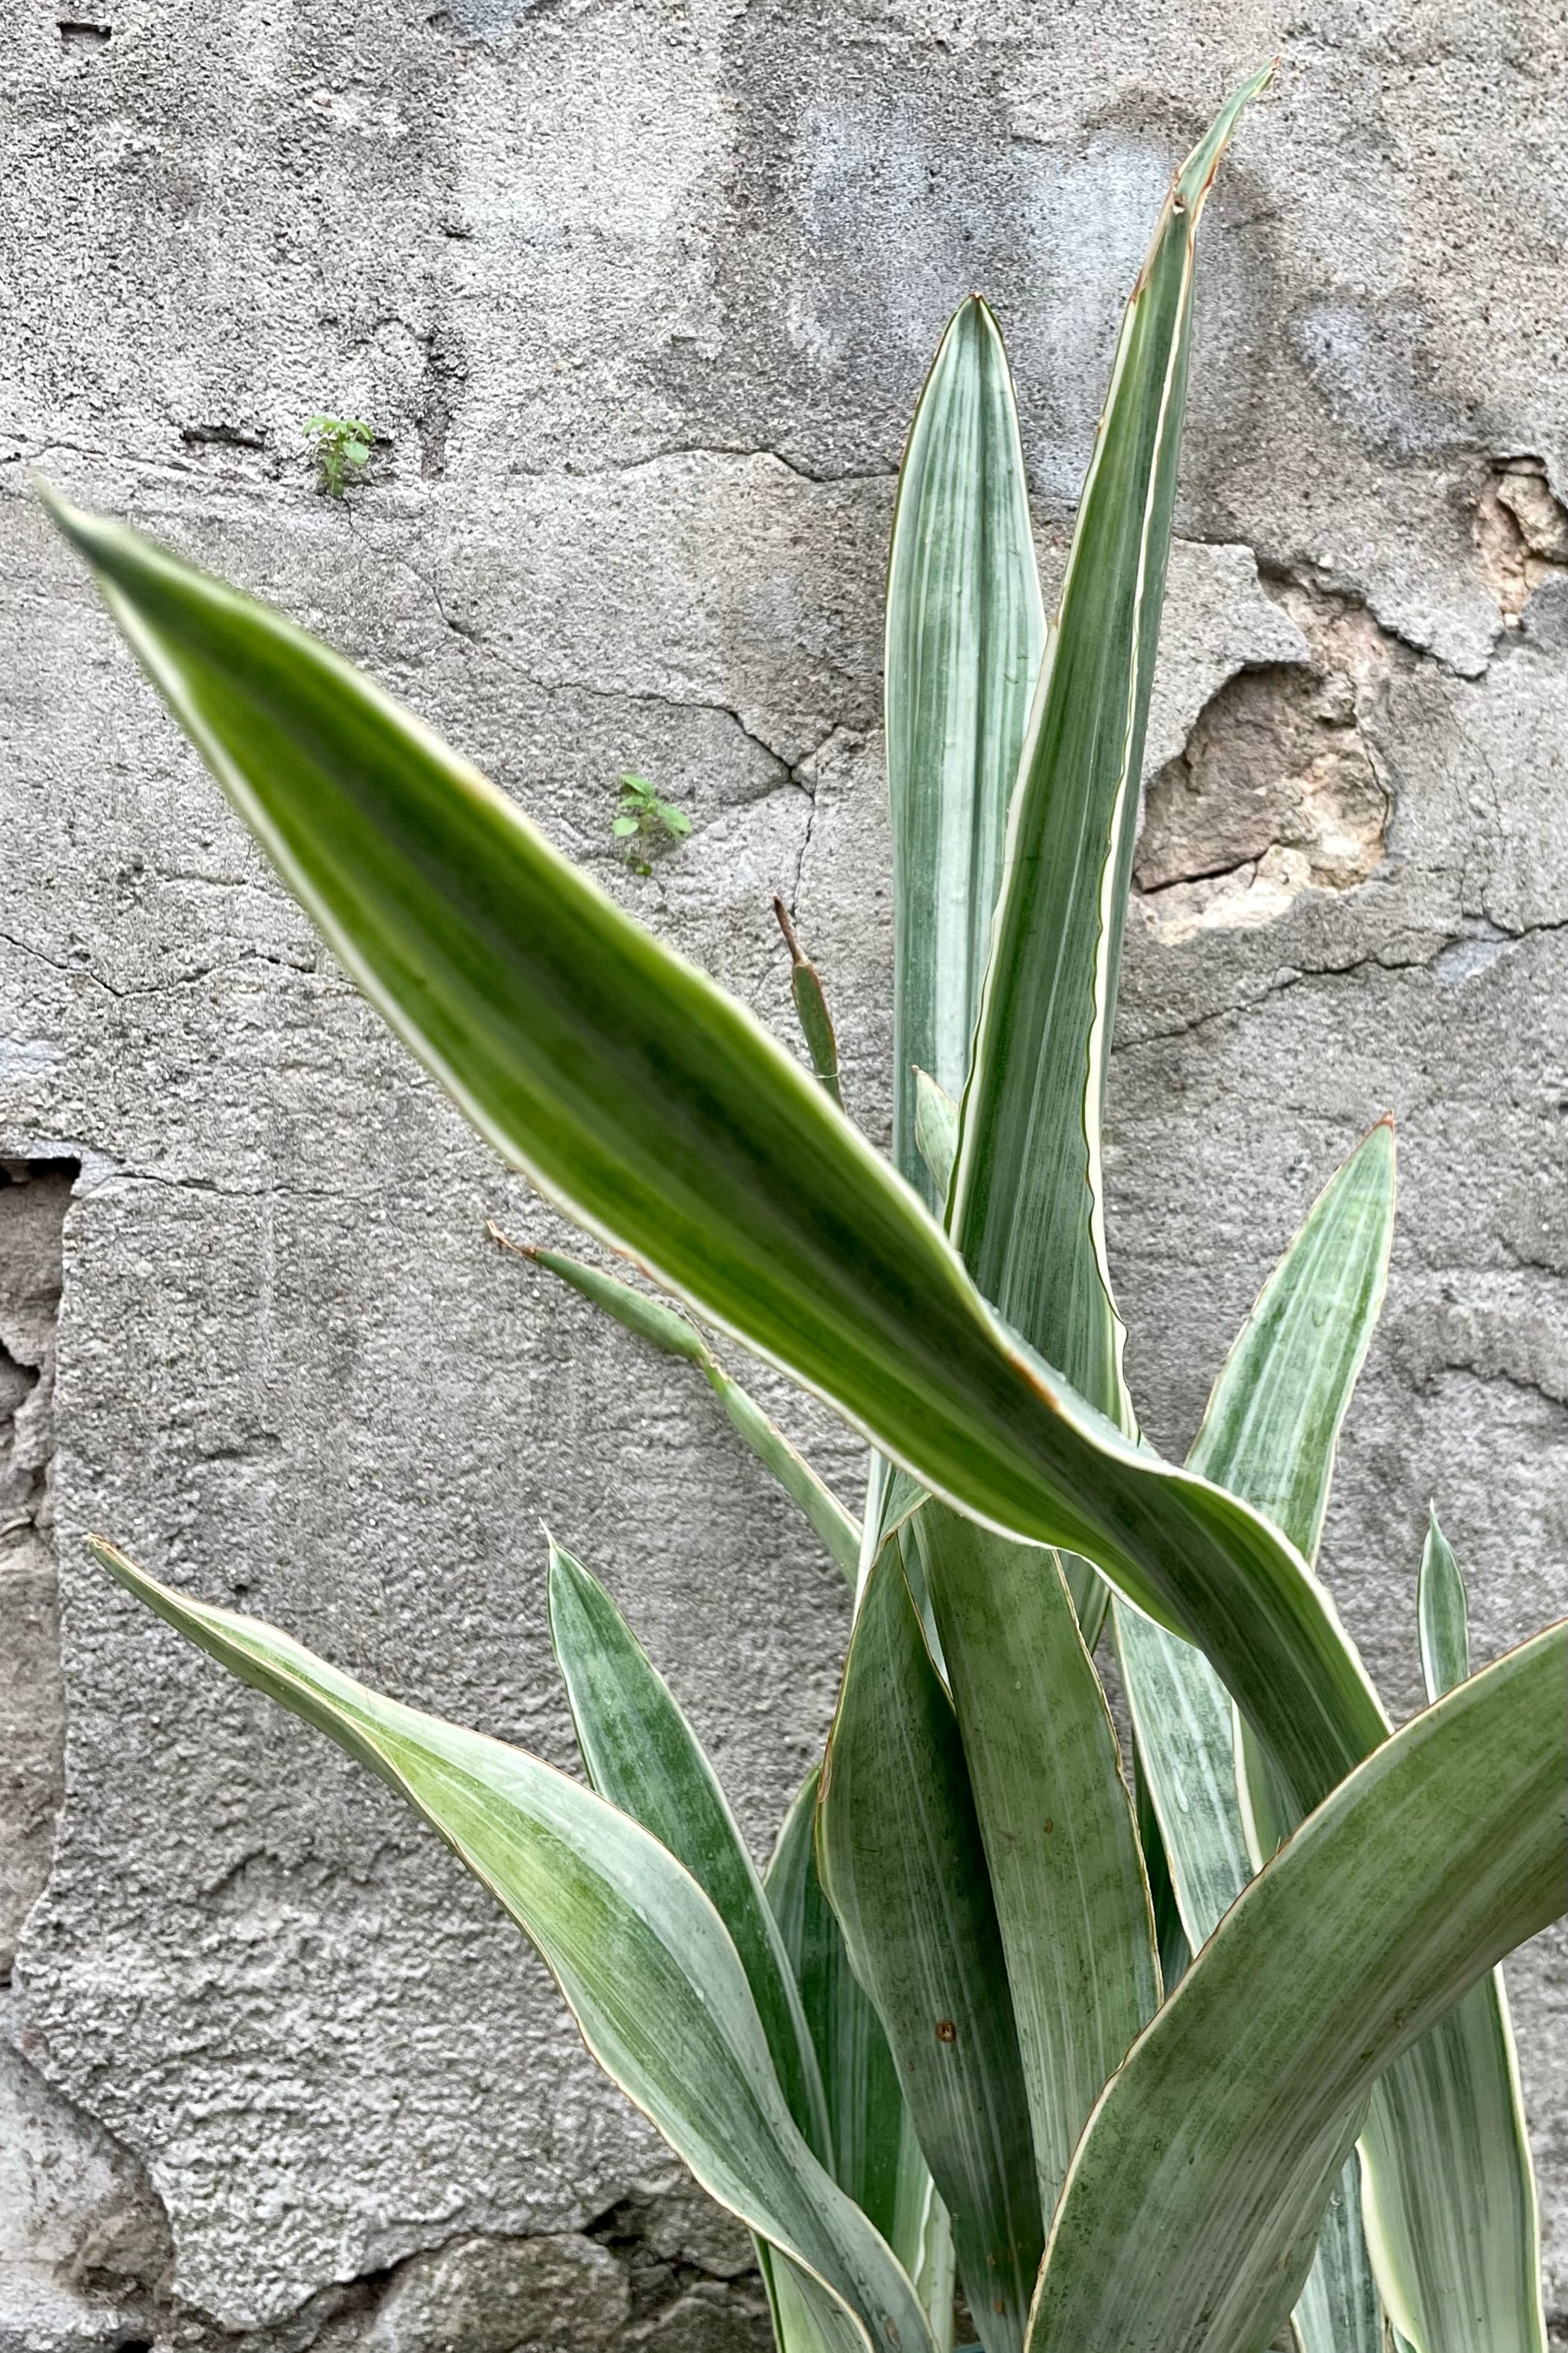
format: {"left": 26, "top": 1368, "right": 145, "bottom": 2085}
{"left": 0, "top": 0, "right": 1568, "bottom": 2353}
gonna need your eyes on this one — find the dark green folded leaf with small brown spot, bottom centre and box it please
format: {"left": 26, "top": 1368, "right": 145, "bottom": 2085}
{"left": 818, "top": 1536, "right": 1044, "bottom": 2353}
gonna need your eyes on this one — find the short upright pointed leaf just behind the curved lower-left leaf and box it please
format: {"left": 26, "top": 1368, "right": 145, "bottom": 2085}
{"left": 550, "top": 1536, "right": 832, "bottom": 2165}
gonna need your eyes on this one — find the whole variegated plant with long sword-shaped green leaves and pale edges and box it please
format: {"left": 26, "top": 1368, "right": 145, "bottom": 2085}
{"left": 43, "top": 76, "right": 1568, "bottom": 2353}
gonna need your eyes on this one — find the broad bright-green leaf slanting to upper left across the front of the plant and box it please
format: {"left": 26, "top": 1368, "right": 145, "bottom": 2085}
{"left": 46, "top": 482, "right": 1383, "bottom": 1835}
